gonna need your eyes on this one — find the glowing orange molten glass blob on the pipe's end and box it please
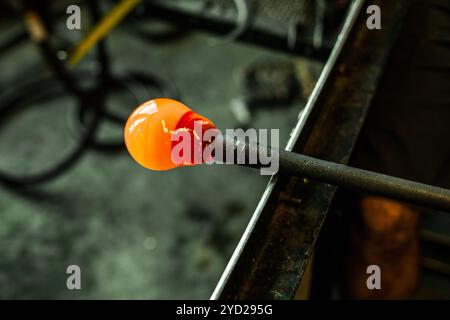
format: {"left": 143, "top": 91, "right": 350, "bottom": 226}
{"left": 124, "top": 98, "right": 216, "bottom": 170}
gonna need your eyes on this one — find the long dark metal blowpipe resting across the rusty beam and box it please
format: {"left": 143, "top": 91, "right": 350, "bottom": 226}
{"left": 220, "top": 137, "right": 450, "bottom": 213}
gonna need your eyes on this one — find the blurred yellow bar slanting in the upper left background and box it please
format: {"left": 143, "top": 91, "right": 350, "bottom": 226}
{"left": 69, "top": 0, "right": 140, "bottom": 67}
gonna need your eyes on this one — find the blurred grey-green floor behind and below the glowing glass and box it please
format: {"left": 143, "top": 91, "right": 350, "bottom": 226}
{"left": 0, "top": 20, "right": 320, "bottom": 299}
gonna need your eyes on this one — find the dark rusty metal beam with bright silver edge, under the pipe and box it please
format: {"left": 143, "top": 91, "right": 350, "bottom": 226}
{"left": 211, "top": 0, "right": 408, "bottom": 299}
